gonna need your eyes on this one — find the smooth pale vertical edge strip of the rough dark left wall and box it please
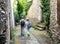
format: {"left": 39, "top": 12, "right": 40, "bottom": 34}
{"left": 6, "top": 0, "right": 10, "bottom": 44}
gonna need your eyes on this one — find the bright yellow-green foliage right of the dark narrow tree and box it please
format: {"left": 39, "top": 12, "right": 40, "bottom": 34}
{"left": 19, "top": 0, "right": 32, "bottom": 16}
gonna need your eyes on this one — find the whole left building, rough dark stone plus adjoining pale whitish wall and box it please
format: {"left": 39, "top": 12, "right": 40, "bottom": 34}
{"left": 0, "top": 0, "right": 14, "bottom": 44}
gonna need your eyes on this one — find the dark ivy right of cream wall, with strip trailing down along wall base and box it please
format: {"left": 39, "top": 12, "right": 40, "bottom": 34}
{"left": 41, "top": 0, "right": 58, "bottom": 44}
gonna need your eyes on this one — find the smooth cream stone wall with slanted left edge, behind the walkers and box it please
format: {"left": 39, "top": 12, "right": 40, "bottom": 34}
{"left": 27, "top": 0, "right": 41, "bottom": 25}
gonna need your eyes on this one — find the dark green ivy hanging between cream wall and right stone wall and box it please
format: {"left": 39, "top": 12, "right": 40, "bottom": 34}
{"left": 41, "top": 0, "right": 50, "bottom": 27}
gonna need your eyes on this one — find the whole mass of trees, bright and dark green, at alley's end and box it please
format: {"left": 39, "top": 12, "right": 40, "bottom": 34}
{"left": 13, "top": 0, "right": 32, "bottom": 22}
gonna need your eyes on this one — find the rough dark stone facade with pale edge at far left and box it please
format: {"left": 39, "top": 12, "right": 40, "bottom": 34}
{"left": 0, "top": 0, "right": 10, "bottom": 44}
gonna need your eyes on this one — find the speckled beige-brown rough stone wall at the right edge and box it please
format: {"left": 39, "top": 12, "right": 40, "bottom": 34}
{"left": 50, "top": 0, "right": 60, "bottom": 44}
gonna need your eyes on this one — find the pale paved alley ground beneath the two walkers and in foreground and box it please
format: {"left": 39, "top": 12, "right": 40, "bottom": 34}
{"left": 15, "top": 26, "right": 51, "bottom": 44}
